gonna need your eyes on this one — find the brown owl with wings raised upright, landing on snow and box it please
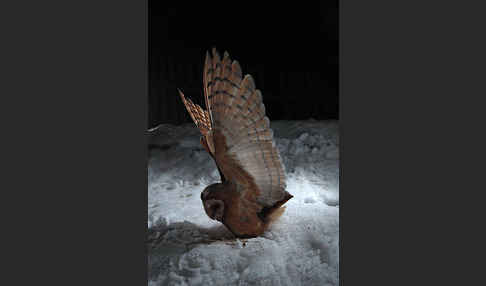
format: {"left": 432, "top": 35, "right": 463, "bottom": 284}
{"left": 178, "top": 48, "right": 293, "bottom": 238}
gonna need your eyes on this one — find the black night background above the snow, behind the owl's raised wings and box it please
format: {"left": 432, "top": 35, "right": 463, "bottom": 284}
{"left": 148, "top": 0, "right": 339, "bottom": 127}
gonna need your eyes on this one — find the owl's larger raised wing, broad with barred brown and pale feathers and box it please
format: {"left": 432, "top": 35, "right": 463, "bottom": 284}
{"left": 204, "top": 48, "right": 292, "bottom": 208}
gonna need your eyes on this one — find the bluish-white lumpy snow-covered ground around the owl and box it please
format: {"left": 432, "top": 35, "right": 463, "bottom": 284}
{"left": 147, "top": 120, "right": 339, "bottom": 285}
